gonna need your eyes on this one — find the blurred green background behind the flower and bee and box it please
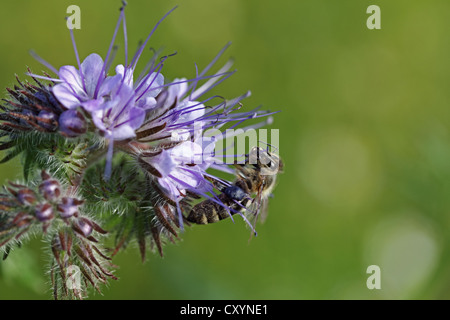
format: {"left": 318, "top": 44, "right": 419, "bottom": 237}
{"left": 0, "top": 0, "right": 450, "bottom": 299}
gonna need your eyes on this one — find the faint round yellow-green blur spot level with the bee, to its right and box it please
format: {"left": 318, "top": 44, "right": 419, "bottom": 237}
{"left": 299, "top": 128, "right": 379, "bottom": 208}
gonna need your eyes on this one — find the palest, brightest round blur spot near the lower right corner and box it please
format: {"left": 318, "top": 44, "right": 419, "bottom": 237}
{"left": 365, "top": 212, "right": 440, "bottom": 299}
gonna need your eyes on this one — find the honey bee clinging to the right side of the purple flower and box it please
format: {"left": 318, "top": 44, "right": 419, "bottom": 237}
{"left": 187, "top": 147, "right": 283, "bottom": 231}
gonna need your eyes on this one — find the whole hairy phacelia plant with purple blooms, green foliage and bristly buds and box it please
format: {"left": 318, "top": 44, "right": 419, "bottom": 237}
{"left": 0, "top": 3, "right": 282, "bottom": 296}
